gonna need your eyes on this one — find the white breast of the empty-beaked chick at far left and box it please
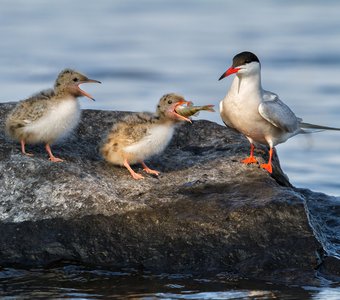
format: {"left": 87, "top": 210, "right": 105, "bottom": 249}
{"left": 25, "top": 98, "right": 80, "bottom": 142}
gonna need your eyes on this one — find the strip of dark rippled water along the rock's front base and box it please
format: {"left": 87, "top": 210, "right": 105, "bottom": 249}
{"left": 0, "top": 265, "right": 340, "bottom": 300}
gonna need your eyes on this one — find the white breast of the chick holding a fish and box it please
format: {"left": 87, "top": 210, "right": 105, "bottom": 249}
{"left": 124, "top": 124, "right": 174, "bottom": 163}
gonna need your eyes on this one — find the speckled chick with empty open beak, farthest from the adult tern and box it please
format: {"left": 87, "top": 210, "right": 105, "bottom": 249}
{"left": 6, "top": 69, "right": 100, "bottom": 162}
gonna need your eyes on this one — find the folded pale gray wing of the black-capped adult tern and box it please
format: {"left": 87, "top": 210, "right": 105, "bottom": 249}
{"left": 259, "top": 91, "right": 301, "bottom": 132}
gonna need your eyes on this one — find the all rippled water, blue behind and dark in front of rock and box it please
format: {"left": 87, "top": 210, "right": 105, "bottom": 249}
{"left": 0, "top": 0, "right": 340, "bottom": 299}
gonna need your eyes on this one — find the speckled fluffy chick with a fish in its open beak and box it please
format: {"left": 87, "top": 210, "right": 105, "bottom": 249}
{"left": 101, "top": 93, "right": 191, "bottom": 179}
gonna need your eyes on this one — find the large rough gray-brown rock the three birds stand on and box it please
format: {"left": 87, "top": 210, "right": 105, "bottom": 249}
{"left": 0, "top": 104, "right": 336, "bottom": 283}
